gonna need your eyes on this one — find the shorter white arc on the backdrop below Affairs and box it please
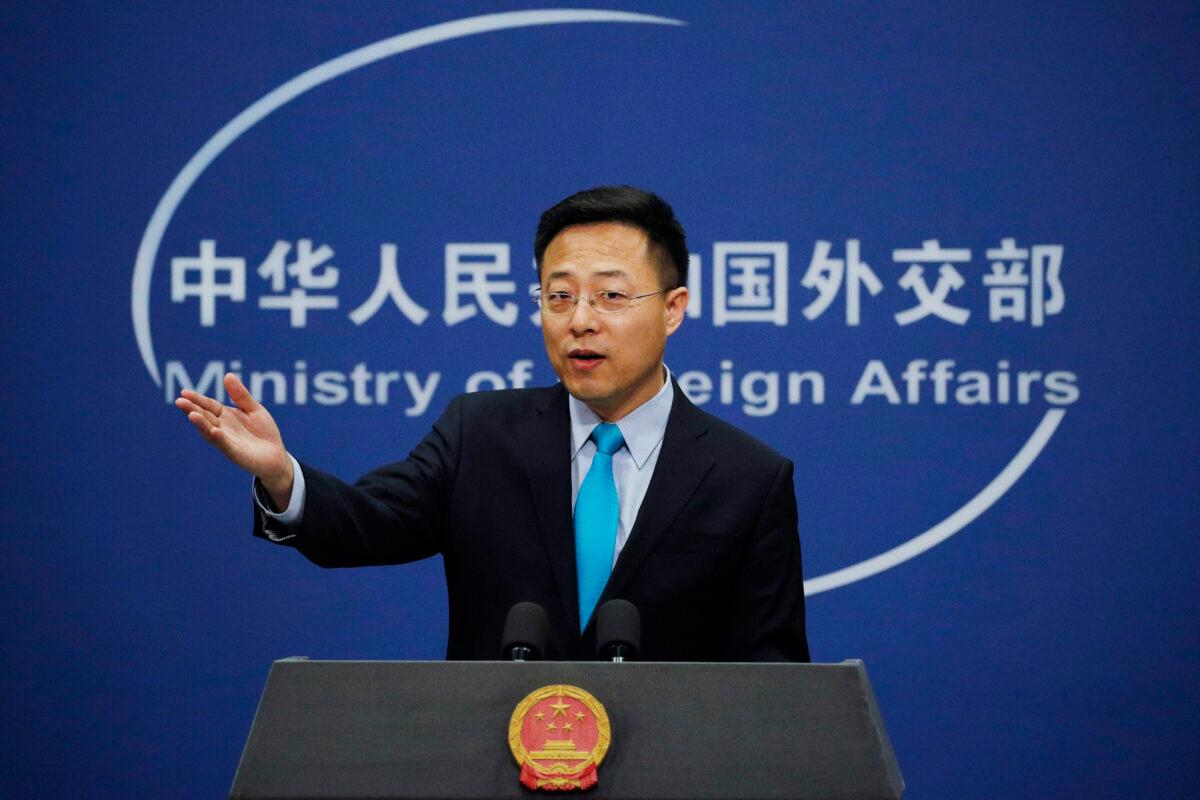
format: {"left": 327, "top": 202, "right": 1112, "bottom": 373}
{"left": 804, "top": 408, "right": 1067, "bottom": 595}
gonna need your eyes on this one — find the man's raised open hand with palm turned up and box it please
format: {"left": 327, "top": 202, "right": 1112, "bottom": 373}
{"left": 175, "top": 373, "right": 294, "bottom": 510}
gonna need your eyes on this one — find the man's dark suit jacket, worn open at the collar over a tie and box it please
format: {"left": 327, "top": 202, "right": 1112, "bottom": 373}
{"left": 254, "top": 385, "right": 809, "bottom": 661}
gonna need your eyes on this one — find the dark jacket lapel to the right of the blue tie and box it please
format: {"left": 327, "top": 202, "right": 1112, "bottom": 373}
{"left": 597, "top": 381, "right": 716, "bottom": 608}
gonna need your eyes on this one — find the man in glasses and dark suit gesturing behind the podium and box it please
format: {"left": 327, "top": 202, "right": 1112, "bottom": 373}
{"left": 176, "top": 187, "right": 809, "bottom": 661}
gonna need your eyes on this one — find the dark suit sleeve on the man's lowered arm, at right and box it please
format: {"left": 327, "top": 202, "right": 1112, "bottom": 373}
{"left": 725, "top": 459, "right": 809, "bottom": 661}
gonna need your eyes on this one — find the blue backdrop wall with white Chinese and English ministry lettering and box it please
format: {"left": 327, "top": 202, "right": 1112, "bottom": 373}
{"left": 0, "top": 0, "right": 1200, "bottom": 798}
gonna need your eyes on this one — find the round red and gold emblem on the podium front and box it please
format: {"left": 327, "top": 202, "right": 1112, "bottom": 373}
{"left": 509, "top": 684, "right": 612, "bottom": 792}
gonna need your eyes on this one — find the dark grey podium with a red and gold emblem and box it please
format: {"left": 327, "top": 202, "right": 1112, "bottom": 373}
{"left": 229, "top": 658, "right": 904, "bottom": 800}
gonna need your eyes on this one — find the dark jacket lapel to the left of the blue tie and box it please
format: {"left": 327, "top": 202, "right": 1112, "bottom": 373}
{"left": 518, "top": 384, "right": 580, "bottom": 631}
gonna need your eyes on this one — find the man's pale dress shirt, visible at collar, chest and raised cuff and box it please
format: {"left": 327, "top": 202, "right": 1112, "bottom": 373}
{"left": 254, "top": 368, "right": 674, "bottom": 563}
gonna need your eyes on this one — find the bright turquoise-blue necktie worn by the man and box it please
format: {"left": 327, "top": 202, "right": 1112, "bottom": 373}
{"left": 575, "top": 422, "right": 625, "bottom": 631}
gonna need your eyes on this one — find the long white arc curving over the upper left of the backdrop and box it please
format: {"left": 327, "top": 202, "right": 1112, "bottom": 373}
{"left": 131, "top": 8, "right": 686, "bottom": 386}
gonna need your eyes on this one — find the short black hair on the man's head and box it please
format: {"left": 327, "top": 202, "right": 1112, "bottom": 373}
{"left": 533, "top": 186, "right": 688, "bottom": 289}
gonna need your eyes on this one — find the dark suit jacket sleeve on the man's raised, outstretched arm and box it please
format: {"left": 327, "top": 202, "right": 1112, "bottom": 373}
{"left": 254, "top": 397, "right": 462, "bottom": 566}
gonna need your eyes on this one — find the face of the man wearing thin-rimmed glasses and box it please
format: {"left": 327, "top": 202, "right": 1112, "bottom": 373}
{"left": 541, "top": 222, "right": 688, "bottom": 422}
